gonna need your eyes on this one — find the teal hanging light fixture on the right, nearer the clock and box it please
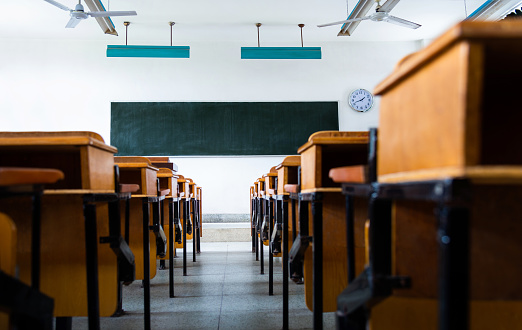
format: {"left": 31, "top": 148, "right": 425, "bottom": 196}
{"left": 241, "top": 23, "right": 321, "bottom": 60}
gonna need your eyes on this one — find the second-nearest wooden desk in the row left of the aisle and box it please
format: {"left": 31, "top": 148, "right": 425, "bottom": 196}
{"left": 114, "top": 156, "right": 165, "bottom": 329}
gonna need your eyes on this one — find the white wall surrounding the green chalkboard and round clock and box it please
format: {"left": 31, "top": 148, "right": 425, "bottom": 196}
{"left": 0, "top": 38, "right": 421, "bottom": 213}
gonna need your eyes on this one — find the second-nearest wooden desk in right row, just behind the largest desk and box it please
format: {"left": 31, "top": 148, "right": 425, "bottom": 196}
{"left": 298, "top": 131, "right": 368, "bottom": 329}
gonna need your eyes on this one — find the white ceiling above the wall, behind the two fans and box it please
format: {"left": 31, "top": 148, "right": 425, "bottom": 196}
{"left": 0, "top": 0, "right": 484, "bottom": 46}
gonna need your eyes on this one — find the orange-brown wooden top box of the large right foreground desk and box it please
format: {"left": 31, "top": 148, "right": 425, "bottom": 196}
{"left": 375, "top": 21, "right": 522, "bottom": 175}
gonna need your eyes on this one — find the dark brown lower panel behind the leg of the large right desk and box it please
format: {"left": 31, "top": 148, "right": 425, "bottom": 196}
{"left": 393, "top": 185, "right": 522, "bottom": 300}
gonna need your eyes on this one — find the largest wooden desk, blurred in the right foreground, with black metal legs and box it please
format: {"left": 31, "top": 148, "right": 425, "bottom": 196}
{"left": 338, "top": 22, "right": 522, "bottom": 329}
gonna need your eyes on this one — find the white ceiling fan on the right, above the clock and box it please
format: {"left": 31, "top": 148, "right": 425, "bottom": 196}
{"left": 317, "top": 0, "right": 421, "bottom": 35}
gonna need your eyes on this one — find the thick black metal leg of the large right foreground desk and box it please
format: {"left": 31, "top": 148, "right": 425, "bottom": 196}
{"left": 438, "top": 205, "right": 469, "bottom": 330}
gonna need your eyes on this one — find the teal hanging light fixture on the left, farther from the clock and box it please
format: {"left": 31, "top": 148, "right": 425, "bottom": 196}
{"left": 107, "top": 22, "right": 190, "bottom": 58}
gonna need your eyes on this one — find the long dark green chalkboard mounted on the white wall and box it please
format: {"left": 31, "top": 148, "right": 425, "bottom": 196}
{"left": 111, "top": 102, "right": 339, "bottom": 156}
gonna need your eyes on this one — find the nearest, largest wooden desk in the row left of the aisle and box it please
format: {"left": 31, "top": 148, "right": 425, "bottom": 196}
{"left": 0, "top": 132, "right": 124, "bottom": 328}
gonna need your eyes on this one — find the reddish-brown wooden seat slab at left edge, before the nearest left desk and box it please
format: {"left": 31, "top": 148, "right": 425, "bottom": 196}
{"left": 0, "top": 167, "right": 64, "bottom": 186}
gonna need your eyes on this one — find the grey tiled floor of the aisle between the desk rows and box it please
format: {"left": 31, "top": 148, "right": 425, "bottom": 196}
{"left": 73, "top": 242, "right": 335, "bottom": 329}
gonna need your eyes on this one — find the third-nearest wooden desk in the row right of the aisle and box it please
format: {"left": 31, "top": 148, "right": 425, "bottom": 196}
{"left": 275, "top": 156, "right": 301, "bottom": 330}
